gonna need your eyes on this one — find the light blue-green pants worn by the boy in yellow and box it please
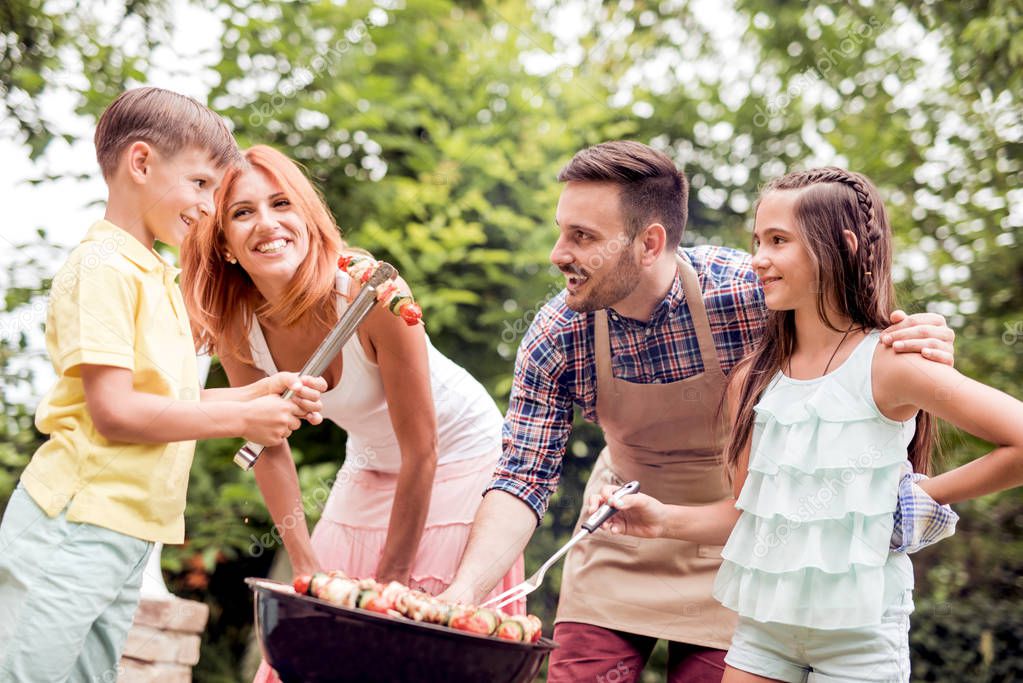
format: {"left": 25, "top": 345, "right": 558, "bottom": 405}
{"left": 0, "top": 486, "right": 152, "bottom": 683}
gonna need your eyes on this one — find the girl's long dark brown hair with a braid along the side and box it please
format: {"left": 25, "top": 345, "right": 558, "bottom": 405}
{"left": 725, "top": 167, "right": 935, "bottom": 473}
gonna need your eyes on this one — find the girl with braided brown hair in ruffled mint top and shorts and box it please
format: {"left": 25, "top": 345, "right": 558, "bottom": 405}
{"left": 591, "top": 168, "right": 1023, "bottom": 683}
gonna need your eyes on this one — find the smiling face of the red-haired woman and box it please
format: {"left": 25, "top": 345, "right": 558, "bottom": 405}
{"left": 221, "top": 169, "right": 309, "bottom": 289}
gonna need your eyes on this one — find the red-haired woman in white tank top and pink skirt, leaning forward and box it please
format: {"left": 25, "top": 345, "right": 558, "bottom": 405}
{"left": 182, "top": 145, "right": 525, "bottom": 680}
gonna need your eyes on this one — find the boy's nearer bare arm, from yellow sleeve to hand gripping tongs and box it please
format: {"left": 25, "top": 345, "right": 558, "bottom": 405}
{"left": 81, "top": 365, "right": 306, "bottom": 446}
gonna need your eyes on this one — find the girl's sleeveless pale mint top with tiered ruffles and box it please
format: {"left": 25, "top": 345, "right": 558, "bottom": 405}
{"left": 714, "top": 330, "right": 916, "bottom": 629}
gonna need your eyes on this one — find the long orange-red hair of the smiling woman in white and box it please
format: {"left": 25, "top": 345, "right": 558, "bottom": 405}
{"left": 181, "top": 145, "right": 345, "bottom": 365}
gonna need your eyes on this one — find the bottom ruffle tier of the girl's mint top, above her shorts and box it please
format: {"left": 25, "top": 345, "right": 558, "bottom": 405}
{"left": 714, "top": 560, "right": 888, "bottom": 629}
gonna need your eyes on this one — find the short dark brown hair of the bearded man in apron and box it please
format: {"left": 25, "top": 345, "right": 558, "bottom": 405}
{"left": 558, "top": 140, "right": 690, "bottom": 249}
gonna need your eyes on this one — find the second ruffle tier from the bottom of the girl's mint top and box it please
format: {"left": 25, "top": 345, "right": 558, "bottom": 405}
{"left": 721, "top": 512, "right": 894, "bottom": 572}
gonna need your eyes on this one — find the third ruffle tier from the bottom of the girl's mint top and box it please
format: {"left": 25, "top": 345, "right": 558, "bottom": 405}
{"left": 736, "top": 462, "right": 905, "bottom": 521}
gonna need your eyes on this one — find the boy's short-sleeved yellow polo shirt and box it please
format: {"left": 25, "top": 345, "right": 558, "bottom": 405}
{"left": 21, "top": 221, "right": 199, "bottom": 543}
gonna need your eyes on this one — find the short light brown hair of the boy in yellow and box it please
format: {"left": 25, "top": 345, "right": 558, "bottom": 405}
{"left": 94, "top": 88, "right": 241, "bottom": 180}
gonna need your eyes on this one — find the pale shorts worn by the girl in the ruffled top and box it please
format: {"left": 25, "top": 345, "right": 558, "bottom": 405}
{"left": 724, "top": 589, "right": 913, "bottom": 683}
